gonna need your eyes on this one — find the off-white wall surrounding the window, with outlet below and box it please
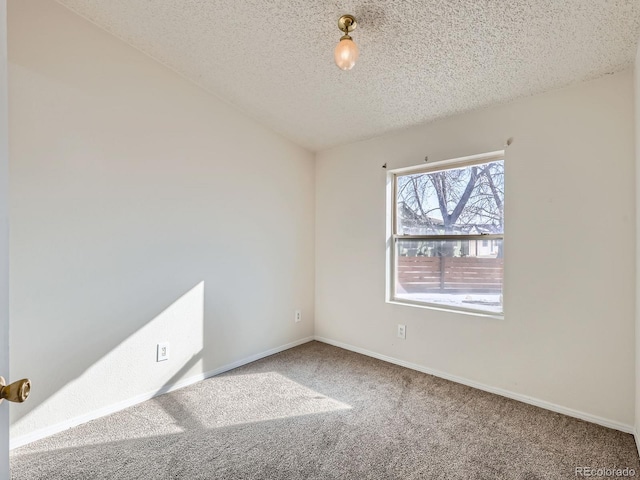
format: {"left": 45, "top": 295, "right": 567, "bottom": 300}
{"left": 316, "top": 71, "right": 636, "bottom": 430}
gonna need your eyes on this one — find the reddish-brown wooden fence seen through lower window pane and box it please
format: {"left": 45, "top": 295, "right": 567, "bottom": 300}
{"left": 397, "top": 257, "right": 504, "bottom": 293}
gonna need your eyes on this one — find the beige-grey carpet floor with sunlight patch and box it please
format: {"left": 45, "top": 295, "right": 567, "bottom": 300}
{"left": 11, "top": 342, "right": 640, "bottom": 480}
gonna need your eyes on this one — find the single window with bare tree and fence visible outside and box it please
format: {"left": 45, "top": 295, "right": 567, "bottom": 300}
{"left": 390, "top": 154, "right": 504, "bottom": 314}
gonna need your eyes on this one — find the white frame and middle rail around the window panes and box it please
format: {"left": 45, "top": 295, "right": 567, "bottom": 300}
{"left": 386, "top": 150, "right": 506, "bottom": 320}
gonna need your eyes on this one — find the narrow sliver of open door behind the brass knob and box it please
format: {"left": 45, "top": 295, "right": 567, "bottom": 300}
{"left": 0, "top": 0, "right": 9, "bottom": 480}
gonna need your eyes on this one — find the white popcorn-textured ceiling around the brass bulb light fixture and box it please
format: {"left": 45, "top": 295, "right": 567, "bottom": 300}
{"left": 59, "top": 0, "right": 640, "bottom": 150}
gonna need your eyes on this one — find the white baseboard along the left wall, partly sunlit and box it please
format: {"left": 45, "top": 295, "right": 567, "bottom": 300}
{"left": 9, "top": 337, "right": 313, "bottom": 450}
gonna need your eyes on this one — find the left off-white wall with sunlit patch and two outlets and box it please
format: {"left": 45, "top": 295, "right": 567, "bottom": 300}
{"left": 5, "top": 0, "right": 314, "bottom": 439}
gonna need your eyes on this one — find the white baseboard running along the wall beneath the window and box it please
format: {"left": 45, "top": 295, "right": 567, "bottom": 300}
{"left": 314, "top": 335, "right": 640, "bottom": 434}
